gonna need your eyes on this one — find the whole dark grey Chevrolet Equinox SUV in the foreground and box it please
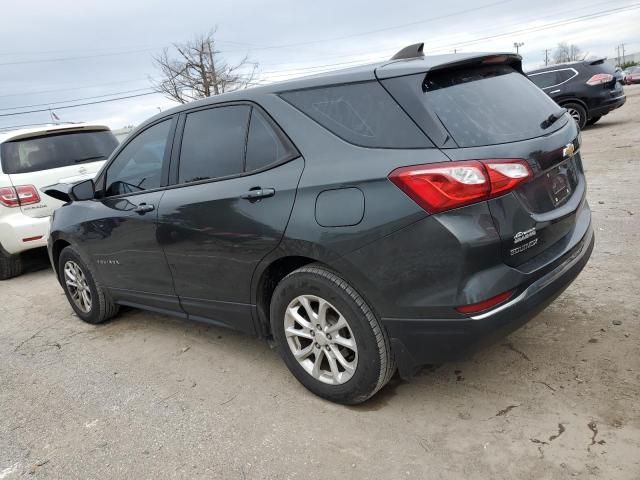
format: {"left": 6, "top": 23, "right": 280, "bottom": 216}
{"left": 47, "top": 45, "right": 594, "bottom": 404}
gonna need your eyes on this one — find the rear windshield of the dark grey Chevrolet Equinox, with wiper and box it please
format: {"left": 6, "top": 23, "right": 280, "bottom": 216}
{"left": 420, "top": 65, "right": 567, "bottom": 147}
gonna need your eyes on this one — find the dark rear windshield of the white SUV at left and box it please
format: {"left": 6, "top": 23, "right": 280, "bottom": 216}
{"left": 0, "top": 130, "right": 118, "bottom": 174}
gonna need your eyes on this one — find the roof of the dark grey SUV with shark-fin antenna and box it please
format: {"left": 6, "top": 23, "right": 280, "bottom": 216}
{"left": 139, "top": 49, "right": 522, "bottom": 134}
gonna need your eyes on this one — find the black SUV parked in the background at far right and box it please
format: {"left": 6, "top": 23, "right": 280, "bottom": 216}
{"left": 527, "top": 58, "right": 626, "bottom": 128}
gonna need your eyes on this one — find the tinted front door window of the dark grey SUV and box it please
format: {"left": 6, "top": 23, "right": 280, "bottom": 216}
{"left": 106, "top": 120, "right": 171, "bottom": 195}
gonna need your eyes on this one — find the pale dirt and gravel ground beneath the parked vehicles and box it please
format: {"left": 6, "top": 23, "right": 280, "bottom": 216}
{"left": 0, "top": 85, "right": 640, "bottom": 480}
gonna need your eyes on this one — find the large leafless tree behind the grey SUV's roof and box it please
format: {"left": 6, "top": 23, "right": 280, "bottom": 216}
{"left": 151, "top": 29, "right": 258, "bottom": 103}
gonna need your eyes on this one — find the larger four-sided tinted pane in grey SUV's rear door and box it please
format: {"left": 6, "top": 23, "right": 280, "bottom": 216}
{"left": 179, "top": 105, "right": 250, "bottom": 183}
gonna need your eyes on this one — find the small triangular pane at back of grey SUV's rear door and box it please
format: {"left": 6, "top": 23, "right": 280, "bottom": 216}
{"left": 245, "top": 108, "right": 295, "bottom": 172}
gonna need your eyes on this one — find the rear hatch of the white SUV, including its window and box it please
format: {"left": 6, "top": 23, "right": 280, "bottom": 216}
{"left": 0, "top": 127, "right": 118, "bottom": 217}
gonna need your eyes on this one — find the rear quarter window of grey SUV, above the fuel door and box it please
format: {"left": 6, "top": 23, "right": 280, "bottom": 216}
{"left": 281, "top": 81, "right": 432, "bottom": 148}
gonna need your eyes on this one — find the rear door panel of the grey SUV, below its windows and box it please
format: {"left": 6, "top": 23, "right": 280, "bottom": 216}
{"left": 158, "top": 157, "right": 304, "bottom": 332}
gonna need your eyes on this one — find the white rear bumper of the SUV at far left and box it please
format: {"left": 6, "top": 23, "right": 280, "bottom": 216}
{"left": 0, "top": 210, "right": 49, "bottom": 255}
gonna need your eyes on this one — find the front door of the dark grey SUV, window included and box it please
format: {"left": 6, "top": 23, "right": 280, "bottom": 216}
{"left": 80, "top": 118, "right": 180, "bottom": 311}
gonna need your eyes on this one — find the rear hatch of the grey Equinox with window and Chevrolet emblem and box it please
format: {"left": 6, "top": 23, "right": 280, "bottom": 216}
{"left": 381, "top": 56, "right": 586, "bottom": 266}
